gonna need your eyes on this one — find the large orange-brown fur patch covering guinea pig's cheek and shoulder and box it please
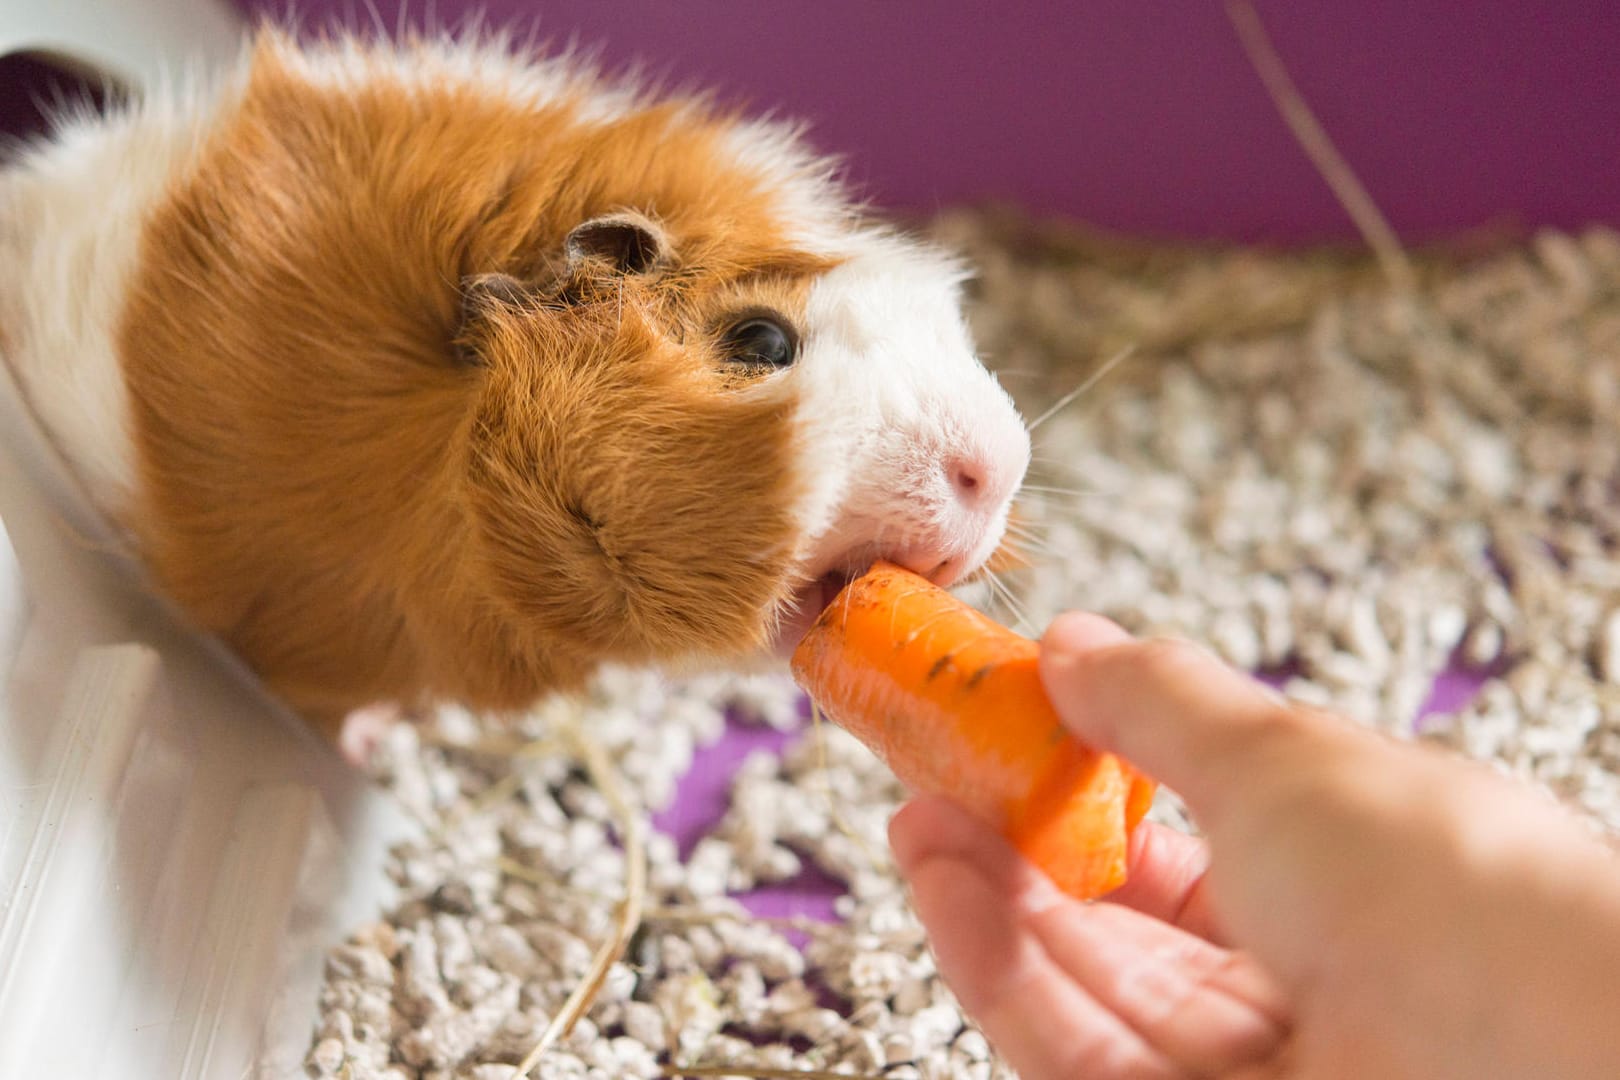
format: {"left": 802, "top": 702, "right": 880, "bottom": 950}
{"left": 120, "top": 39, "right": 828, "bottom": 727}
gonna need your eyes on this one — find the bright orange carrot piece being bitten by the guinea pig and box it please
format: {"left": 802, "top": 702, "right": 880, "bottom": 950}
{"left": 792, "top": 562, "right": 1155, "bottom": 899}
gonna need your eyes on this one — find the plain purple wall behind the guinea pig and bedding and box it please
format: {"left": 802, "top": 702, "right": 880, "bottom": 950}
{"left": 3, "top": 0, "right": 1620, "bottom": 241}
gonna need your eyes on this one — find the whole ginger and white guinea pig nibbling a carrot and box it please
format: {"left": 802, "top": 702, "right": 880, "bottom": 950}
{"left": 0, "top": 31, "right": 1029, "bottom": 732}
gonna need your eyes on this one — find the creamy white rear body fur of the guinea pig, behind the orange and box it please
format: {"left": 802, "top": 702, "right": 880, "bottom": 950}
{"left": 0, "top": 66, "right": 239, "bottom": 521}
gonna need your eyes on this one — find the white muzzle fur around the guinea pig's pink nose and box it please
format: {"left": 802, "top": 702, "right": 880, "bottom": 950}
{"left": 791, "top": 235, "right": 1030, "bottom": 581}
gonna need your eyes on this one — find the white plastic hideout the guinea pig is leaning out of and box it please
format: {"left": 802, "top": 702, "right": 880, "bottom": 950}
{"left": 0, "top": 0, "right": 407, "bottom": 1080}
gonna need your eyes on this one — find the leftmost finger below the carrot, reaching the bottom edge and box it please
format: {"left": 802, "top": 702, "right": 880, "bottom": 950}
{"left": 891, "top": 808, "right": 1183, "bottom": 1080}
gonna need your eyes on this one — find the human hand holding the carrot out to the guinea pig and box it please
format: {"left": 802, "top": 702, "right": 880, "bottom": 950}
{"left": 891, "top": 615, "right": 1620, "bottom": 1080}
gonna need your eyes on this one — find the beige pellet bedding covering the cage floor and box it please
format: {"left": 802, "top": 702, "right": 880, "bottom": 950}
{"left": 306, "top": 212, "right": 1620, "bottom": 1080}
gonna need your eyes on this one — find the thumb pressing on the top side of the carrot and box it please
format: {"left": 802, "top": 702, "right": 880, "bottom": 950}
{"left": 1040, "top": 614, "right": 1333, "bottom": 827}
